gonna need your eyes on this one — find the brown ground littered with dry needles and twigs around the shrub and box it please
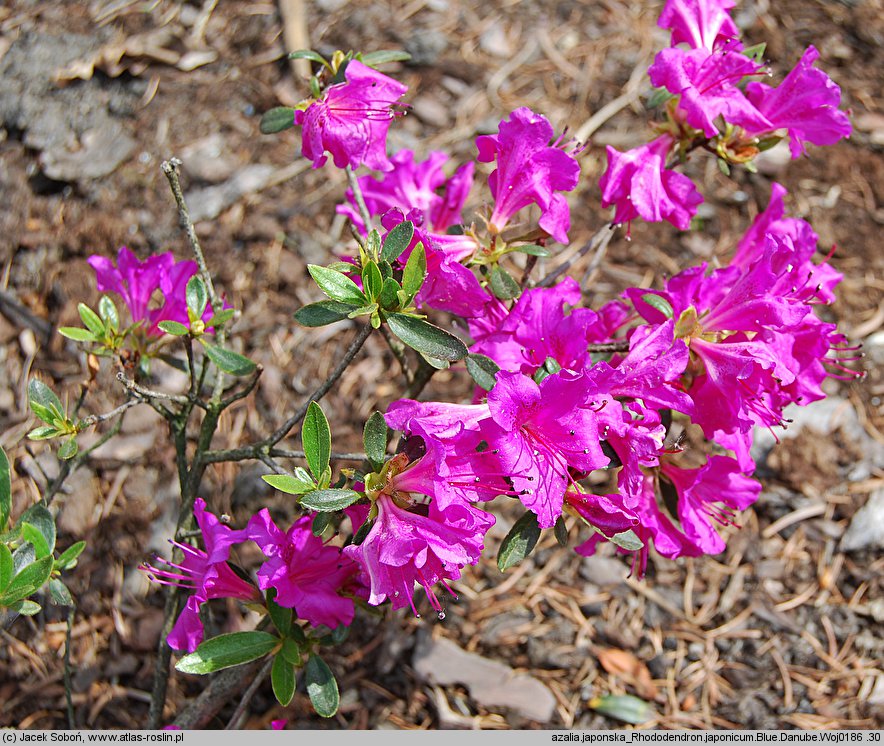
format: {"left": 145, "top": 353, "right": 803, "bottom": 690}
{"left": 0, "top": 0, "right": 884, "bottom": 728}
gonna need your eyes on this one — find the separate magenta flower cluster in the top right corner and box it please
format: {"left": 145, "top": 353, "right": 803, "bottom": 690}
{"left": 599, "top": 0, "right": 851, "bottom": 230}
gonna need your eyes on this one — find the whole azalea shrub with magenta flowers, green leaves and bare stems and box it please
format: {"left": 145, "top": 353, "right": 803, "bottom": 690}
{"left": 10, "top": 0, "right": 857, "bottom": 725}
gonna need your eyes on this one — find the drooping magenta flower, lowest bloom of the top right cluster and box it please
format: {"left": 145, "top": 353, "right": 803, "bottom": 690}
{"left": 599, "top": 135, "right": 703, "bottom": 230}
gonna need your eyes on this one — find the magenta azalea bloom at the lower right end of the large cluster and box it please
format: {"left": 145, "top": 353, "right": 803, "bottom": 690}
{"left": 660, "top": 456, "right": 761, "bottom": 554}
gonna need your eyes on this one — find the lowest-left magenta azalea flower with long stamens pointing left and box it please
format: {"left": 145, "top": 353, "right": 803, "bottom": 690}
{"left": 141, "top": 498, "right": 260, "bottom": 653}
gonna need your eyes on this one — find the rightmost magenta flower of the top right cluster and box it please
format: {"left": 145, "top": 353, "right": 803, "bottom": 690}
{"left": 746, "top": 46, "right": 851, "bottom": 158}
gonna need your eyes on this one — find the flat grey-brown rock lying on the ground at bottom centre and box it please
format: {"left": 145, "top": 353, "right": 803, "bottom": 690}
{"left": 412, "top": 632, "right": 556, "bottom": 723}
